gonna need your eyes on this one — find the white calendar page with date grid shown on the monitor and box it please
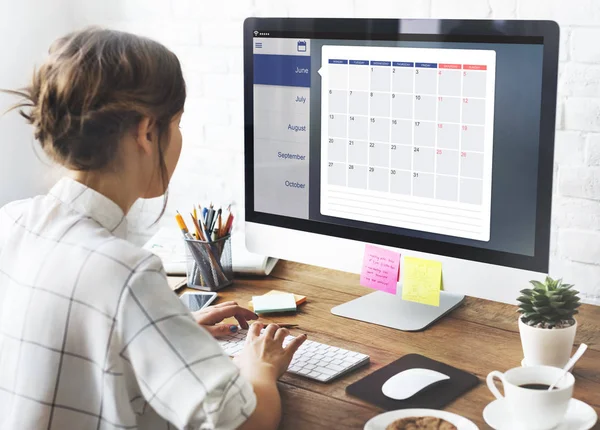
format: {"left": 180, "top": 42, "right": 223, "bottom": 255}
{"left": 319, "top": 45, "right": 496, "bottom": 241}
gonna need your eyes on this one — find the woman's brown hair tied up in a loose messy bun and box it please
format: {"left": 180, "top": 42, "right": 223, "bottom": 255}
{"left": 7, "top": 28, "right": 186, "bottom": 215}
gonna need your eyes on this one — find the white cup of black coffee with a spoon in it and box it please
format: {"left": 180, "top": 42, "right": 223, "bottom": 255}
{"left": 487, "top": 366, "right": 575, "bottom": 430}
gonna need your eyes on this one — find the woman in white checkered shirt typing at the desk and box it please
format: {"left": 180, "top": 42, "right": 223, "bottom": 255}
{"left": 0, "top": 29, "right": 306, "bottom": 430}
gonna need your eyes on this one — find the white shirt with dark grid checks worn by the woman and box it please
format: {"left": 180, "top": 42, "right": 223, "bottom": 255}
{"left": 0, "top": 178, "right": 256, "bottom": 430}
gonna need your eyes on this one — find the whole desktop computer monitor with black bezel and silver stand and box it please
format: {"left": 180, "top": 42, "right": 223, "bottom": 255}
{"left": 244, "top": 18, "right": 559, "bottom": 330}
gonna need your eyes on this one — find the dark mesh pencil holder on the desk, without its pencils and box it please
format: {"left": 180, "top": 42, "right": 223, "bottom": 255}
{"left": 184, "top": 235, "right": 233, "bottom": 291}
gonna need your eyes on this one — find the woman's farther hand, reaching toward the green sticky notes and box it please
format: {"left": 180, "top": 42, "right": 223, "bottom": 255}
{"left": 192, "top": 302, "right": 258, "bottom": 337}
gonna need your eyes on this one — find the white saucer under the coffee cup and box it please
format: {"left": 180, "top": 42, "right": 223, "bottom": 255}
{"left": 483, "top": 399, "right": 598, "bottom": 430}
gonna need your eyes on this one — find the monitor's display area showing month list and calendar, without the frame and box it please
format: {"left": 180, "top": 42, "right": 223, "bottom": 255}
{"left": 246, "top": 20, "right": 554, "bottom": 272}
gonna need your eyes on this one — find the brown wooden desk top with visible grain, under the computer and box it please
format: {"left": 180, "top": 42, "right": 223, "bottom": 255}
{"left": 174, "top": 261, "right": 600, "bottom": 430}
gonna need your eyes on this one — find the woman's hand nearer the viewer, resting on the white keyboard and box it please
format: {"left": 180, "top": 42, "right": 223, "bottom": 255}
{"left": 233, "top": 322, "right": 306, "bottom": 381}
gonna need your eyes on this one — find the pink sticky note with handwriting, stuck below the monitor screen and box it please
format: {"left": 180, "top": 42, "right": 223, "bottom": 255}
{"left": 360, "top": 245, "right": 400, "bottom": 294}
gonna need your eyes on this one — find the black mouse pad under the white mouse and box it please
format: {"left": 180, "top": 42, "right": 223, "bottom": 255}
{"left": 346, "top": 354, "right": 479, "bottom": 410}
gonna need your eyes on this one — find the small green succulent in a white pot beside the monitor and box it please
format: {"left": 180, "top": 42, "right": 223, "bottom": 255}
{"left": 517, "top": 277, "right": 581, "bottom": 367}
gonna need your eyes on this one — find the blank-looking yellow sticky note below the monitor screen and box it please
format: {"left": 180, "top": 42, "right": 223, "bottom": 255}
{"left": 402, "top": 257, "right": 442, "bottom": 306}
